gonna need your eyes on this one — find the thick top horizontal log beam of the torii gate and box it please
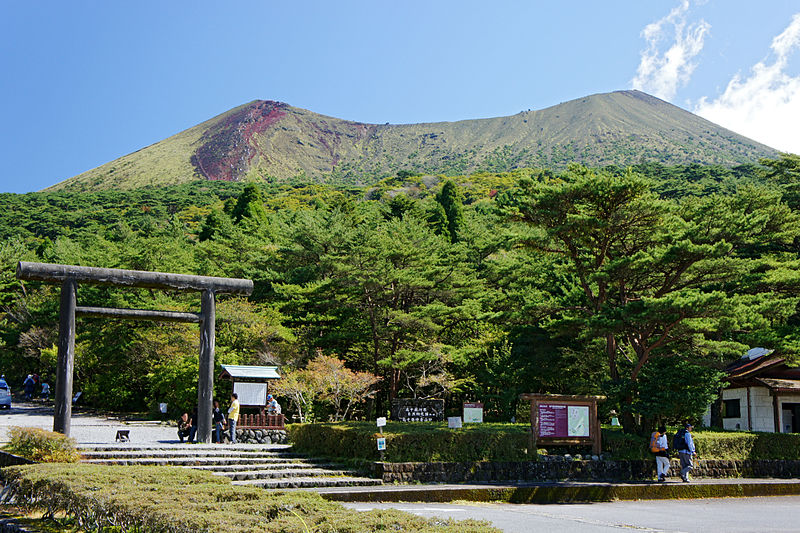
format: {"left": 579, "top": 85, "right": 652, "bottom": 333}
{"left": 17, "top": 261, "right": 253, "bottom": 294}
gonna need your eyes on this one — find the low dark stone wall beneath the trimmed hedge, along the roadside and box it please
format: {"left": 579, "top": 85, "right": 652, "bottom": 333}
{"left": 375, "top": 459, "right": 800, "bottom": 483}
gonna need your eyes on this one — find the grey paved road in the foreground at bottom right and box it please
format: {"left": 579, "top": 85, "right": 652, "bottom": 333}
{"left": 343, "top": 496, "right": 800, "bottom": 533}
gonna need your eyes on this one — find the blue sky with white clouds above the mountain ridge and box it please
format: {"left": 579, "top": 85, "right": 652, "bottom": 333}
{"left": 0, "top": 0, "right": 800, "bottom": 192}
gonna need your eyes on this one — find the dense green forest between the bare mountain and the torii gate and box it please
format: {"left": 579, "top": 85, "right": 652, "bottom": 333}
{"left": 0, "top": 154, "right": 800, "bottom": 432}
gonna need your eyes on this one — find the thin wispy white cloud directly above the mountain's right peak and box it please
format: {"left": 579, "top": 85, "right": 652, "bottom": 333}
{"left": 631, "top": 0, "right": 711, "bottom": 100}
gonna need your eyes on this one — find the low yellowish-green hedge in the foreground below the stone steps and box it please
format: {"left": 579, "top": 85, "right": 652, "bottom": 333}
{"left": 2, "top": 464, "right": 498, "bottom": 533}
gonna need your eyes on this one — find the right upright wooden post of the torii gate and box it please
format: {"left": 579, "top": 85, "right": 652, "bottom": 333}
{"left": 197, "top": 289, "right": 216, "bottom": 443}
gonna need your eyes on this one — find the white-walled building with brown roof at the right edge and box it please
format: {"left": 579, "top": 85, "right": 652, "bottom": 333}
{"left": 703, "top": 348, "right": 800, "bottom": 433}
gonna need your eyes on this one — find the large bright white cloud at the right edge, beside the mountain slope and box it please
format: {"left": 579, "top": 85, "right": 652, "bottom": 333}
{"left": 694, "top": 13, "right": 800, "bottom": 153}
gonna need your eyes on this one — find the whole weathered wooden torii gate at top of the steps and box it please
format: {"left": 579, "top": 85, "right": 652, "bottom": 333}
{"left": 17, "top": 262, "right": 253, "bottom": 442}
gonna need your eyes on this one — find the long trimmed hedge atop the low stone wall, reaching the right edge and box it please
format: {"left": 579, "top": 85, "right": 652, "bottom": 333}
{"left": 287, "top": 422, "right": 800, "bottom": 463}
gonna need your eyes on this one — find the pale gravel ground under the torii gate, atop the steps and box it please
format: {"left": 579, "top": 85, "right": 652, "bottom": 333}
{"left": 0, "top": 402, "right": 178, "bottom": 444}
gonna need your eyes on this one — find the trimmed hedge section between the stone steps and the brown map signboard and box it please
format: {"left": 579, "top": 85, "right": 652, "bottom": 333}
{"left": 288, "top": 422, "right": 535, "bottom": 462}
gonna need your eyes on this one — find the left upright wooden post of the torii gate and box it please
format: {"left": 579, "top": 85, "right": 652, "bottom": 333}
{"left": 53, "top": 279, "right": 78, "bottom": 436}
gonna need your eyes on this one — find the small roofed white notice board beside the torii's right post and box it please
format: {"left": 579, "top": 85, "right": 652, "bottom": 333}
{"left": 219, "top": 365, "right": 286, "bottom": 429}
